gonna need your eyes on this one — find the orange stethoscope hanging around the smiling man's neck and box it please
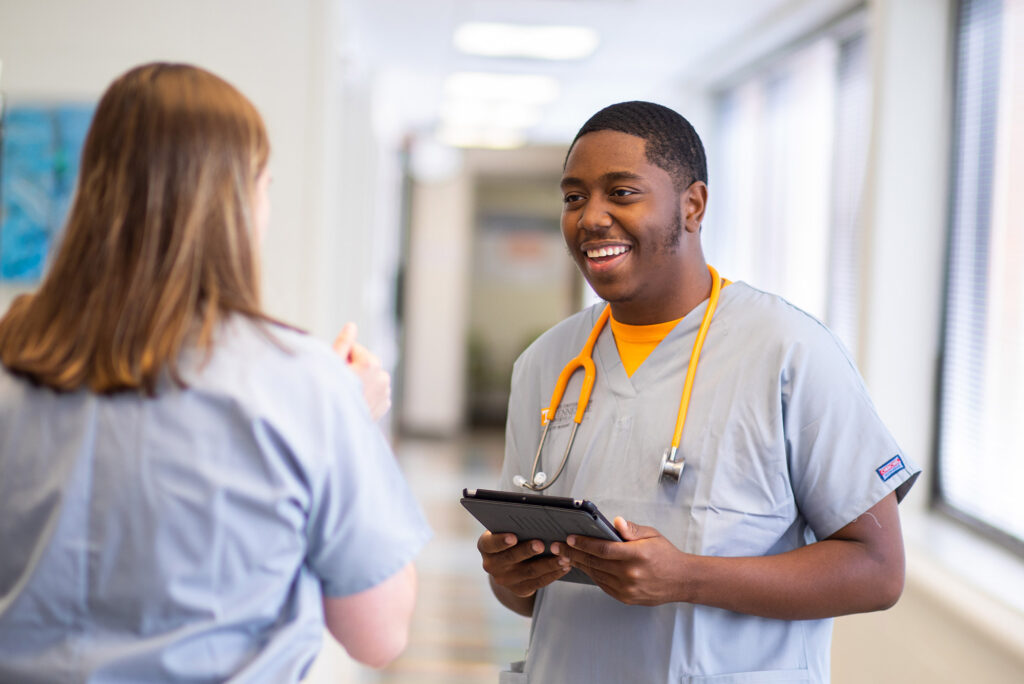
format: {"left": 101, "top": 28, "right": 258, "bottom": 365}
{"left": 512, "top": 264, "right": 729, "bottom": 491}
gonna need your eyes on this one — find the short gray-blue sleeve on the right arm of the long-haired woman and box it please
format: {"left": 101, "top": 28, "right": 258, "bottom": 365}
{"left": 306, "top": 369, "right": 431, "bottom": 597}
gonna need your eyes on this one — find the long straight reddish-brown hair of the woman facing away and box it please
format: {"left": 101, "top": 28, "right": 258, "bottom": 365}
{"left": 0, "top": 63, "right": 269, "bottom": 394}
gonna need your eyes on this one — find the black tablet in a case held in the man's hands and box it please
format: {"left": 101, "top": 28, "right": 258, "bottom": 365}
{"left": 460, "top": 489, "right": 623, "bottom": 585}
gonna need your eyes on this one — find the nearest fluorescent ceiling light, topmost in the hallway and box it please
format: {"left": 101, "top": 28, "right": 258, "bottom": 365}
{"left": 454, "top": 22, "right": 598, "bottom": 59}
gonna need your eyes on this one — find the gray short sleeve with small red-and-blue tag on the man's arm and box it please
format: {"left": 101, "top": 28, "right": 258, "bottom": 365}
{"left": 780, "top": 316, "right": 921, "bottom": 540}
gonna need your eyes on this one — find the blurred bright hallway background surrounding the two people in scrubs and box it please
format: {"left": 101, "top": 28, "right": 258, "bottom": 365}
{"left": 0, "top": 0, "right": 1024, "bottom": 684}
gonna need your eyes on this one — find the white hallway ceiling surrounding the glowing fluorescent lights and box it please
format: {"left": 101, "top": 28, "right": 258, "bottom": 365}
{"left": 345, "top": 0, "right": 859, "bottom": 144}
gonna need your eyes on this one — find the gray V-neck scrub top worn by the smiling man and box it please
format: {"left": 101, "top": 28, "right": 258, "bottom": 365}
{"left": 501, "top": 283, "right": 920, "bottom": 684}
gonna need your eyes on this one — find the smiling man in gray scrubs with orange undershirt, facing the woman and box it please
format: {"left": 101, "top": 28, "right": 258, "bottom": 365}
{"left": 478, "top": 102, "right": 920, "bottom": 684}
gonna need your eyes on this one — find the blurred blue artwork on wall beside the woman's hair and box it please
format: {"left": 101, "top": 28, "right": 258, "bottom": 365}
{"left": 0, "top": 104, "right": 95, "bottom": 283}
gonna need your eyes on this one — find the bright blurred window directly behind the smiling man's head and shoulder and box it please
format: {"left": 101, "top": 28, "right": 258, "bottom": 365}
{"left": 706, "top": 14, "right": 870, "bottom": 352}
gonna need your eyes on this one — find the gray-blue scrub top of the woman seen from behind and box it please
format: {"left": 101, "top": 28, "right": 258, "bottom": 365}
{"left": 0, "top": 316, "right": 430, "bottom": 684}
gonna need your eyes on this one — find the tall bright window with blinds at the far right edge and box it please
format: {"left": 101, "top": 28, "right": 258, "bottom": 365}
{"left": 937, "top": 0, "right": 1024, "bottom": 553}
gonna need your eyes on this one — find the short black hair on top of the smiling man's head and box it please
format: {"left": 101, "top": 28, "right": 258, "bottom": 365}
{"left": 565, "top": 100, "right": 708, "bottom": 191}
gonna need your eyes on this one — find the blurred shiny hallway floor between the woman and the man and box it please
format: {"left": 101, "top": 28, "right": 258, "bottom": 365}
{"left": 305, "top": 430, "right": 529, "bottom": 684}
